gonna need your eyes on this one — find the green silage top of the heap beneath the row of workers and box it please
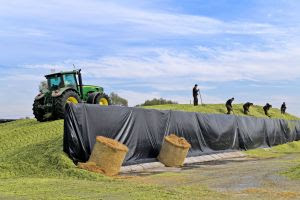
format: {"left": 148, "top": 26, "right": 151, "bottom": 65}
{"left": 143, "top": 104, "right": 300, "bottom": 120}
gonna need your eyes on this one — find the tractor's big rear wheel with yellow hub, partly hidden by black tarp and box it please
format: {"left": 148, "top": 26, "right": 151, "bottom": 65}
{"left": 54, "top": 90, "right": 81, "bottom": 119}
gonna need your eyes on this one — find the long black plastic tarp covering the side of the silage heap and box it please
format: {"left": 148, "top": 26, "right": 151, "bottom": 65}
{"left": 63, "top": 104, "right": 300, "bottom": 165}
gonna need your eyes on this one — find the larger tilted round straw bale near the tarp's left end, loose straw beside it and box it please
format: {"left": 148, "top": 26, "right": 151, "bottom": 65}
{"left": 88, "top": 136, "right": 128, "bottom": 176}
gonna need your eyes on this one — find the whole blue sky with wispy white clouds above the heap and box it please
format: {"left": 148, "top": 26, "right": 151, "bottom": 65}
{"left": 0, "top": 0, "right": 300, "bottom": 118}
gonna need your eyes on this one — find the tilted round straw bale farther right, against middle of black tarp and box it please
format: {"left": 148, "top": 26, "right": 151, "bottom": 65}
{"left": 157, "top": 134, "right": 191, "bottom": 167}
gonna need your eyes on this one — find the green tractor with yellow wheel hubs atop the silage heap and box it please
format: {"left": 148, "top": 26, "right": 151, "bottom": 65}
{"left": 32, "top": 69, "right": 111, "bottom": 122}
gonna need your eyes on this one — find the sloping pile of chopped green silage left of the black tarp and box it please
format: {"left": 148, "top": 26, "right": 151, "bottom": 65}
{"left": 0, "top": 120, "right": 104, "bottom": 179}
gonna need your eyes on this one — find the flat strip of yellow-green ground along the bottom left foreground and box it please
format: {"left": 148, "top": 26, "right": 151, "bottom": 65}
{"left": 0, "top": 178, "right": 228, "bottom": 200}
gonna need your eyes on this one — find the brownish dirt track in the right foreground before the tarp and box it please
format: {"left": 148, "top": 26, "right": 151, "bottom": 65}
{"left": 124, "top": 153, "right": 300, "bottom": 199}
